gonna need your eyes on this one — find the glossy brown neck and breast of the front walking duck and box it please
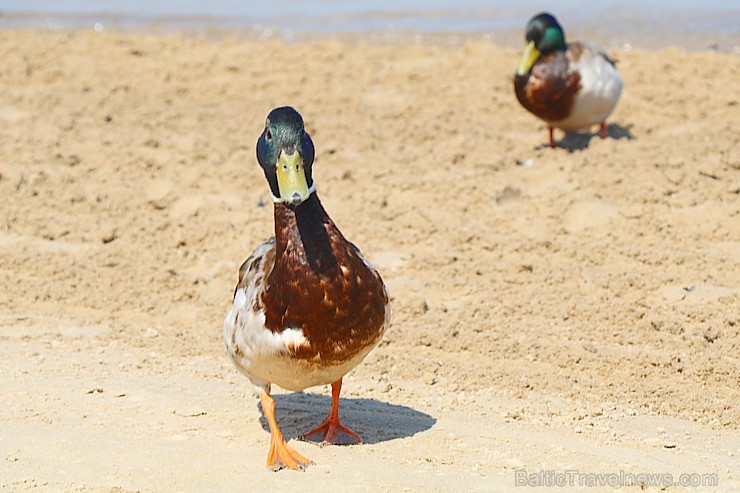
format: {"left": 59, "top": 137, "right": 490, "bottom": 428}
{"left": 261, "top": 193, "right": 388, "bottom": 362}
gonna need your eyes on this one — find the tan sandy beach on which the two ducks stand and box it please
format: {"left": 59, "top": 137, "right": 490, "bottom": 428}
{"left": 0, "top": 31, "right": 740, "bottom": 493}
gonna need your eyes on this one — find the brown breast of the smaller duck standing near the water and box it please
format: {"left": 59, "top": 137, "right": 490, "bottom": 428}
{"left": 514, "top": 51, "right": 581, "bottom": 121}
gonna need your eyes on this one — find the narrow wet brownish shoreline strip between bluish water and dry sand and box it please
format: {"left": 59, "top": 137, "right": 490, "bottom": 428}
{"left": 0, "top": 13, "right": 740, "bottom": 53}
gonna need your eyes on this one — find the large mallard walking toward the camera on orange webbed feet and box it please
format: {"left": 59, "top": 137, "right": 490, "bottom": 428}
{"left": 224, "top": 107, "right": 391, "bottom": 470}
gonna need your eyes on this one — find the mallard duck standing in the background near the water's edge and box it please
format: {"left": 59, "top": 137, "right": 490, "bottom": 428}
{"left": 514, "top": 13, "right": 622, "bottom": 147}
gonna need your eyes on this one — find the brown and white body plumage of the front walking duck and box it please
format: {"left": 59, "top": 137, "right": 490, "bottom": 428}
{"left": 224, "top": 193, "right": 390, "bottom": 390}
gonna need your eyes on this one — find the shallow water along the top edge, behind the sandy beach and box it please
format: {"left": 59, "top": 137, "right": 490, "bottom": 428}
{"left": 0, "top": 0, "right": 740, "bottom": 51}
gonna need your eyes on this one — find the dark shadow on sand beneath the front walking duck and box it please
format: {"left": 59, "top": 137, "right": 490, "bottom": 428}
{"left": 257, "top": 392, "right": 437, "bottom": 444}
